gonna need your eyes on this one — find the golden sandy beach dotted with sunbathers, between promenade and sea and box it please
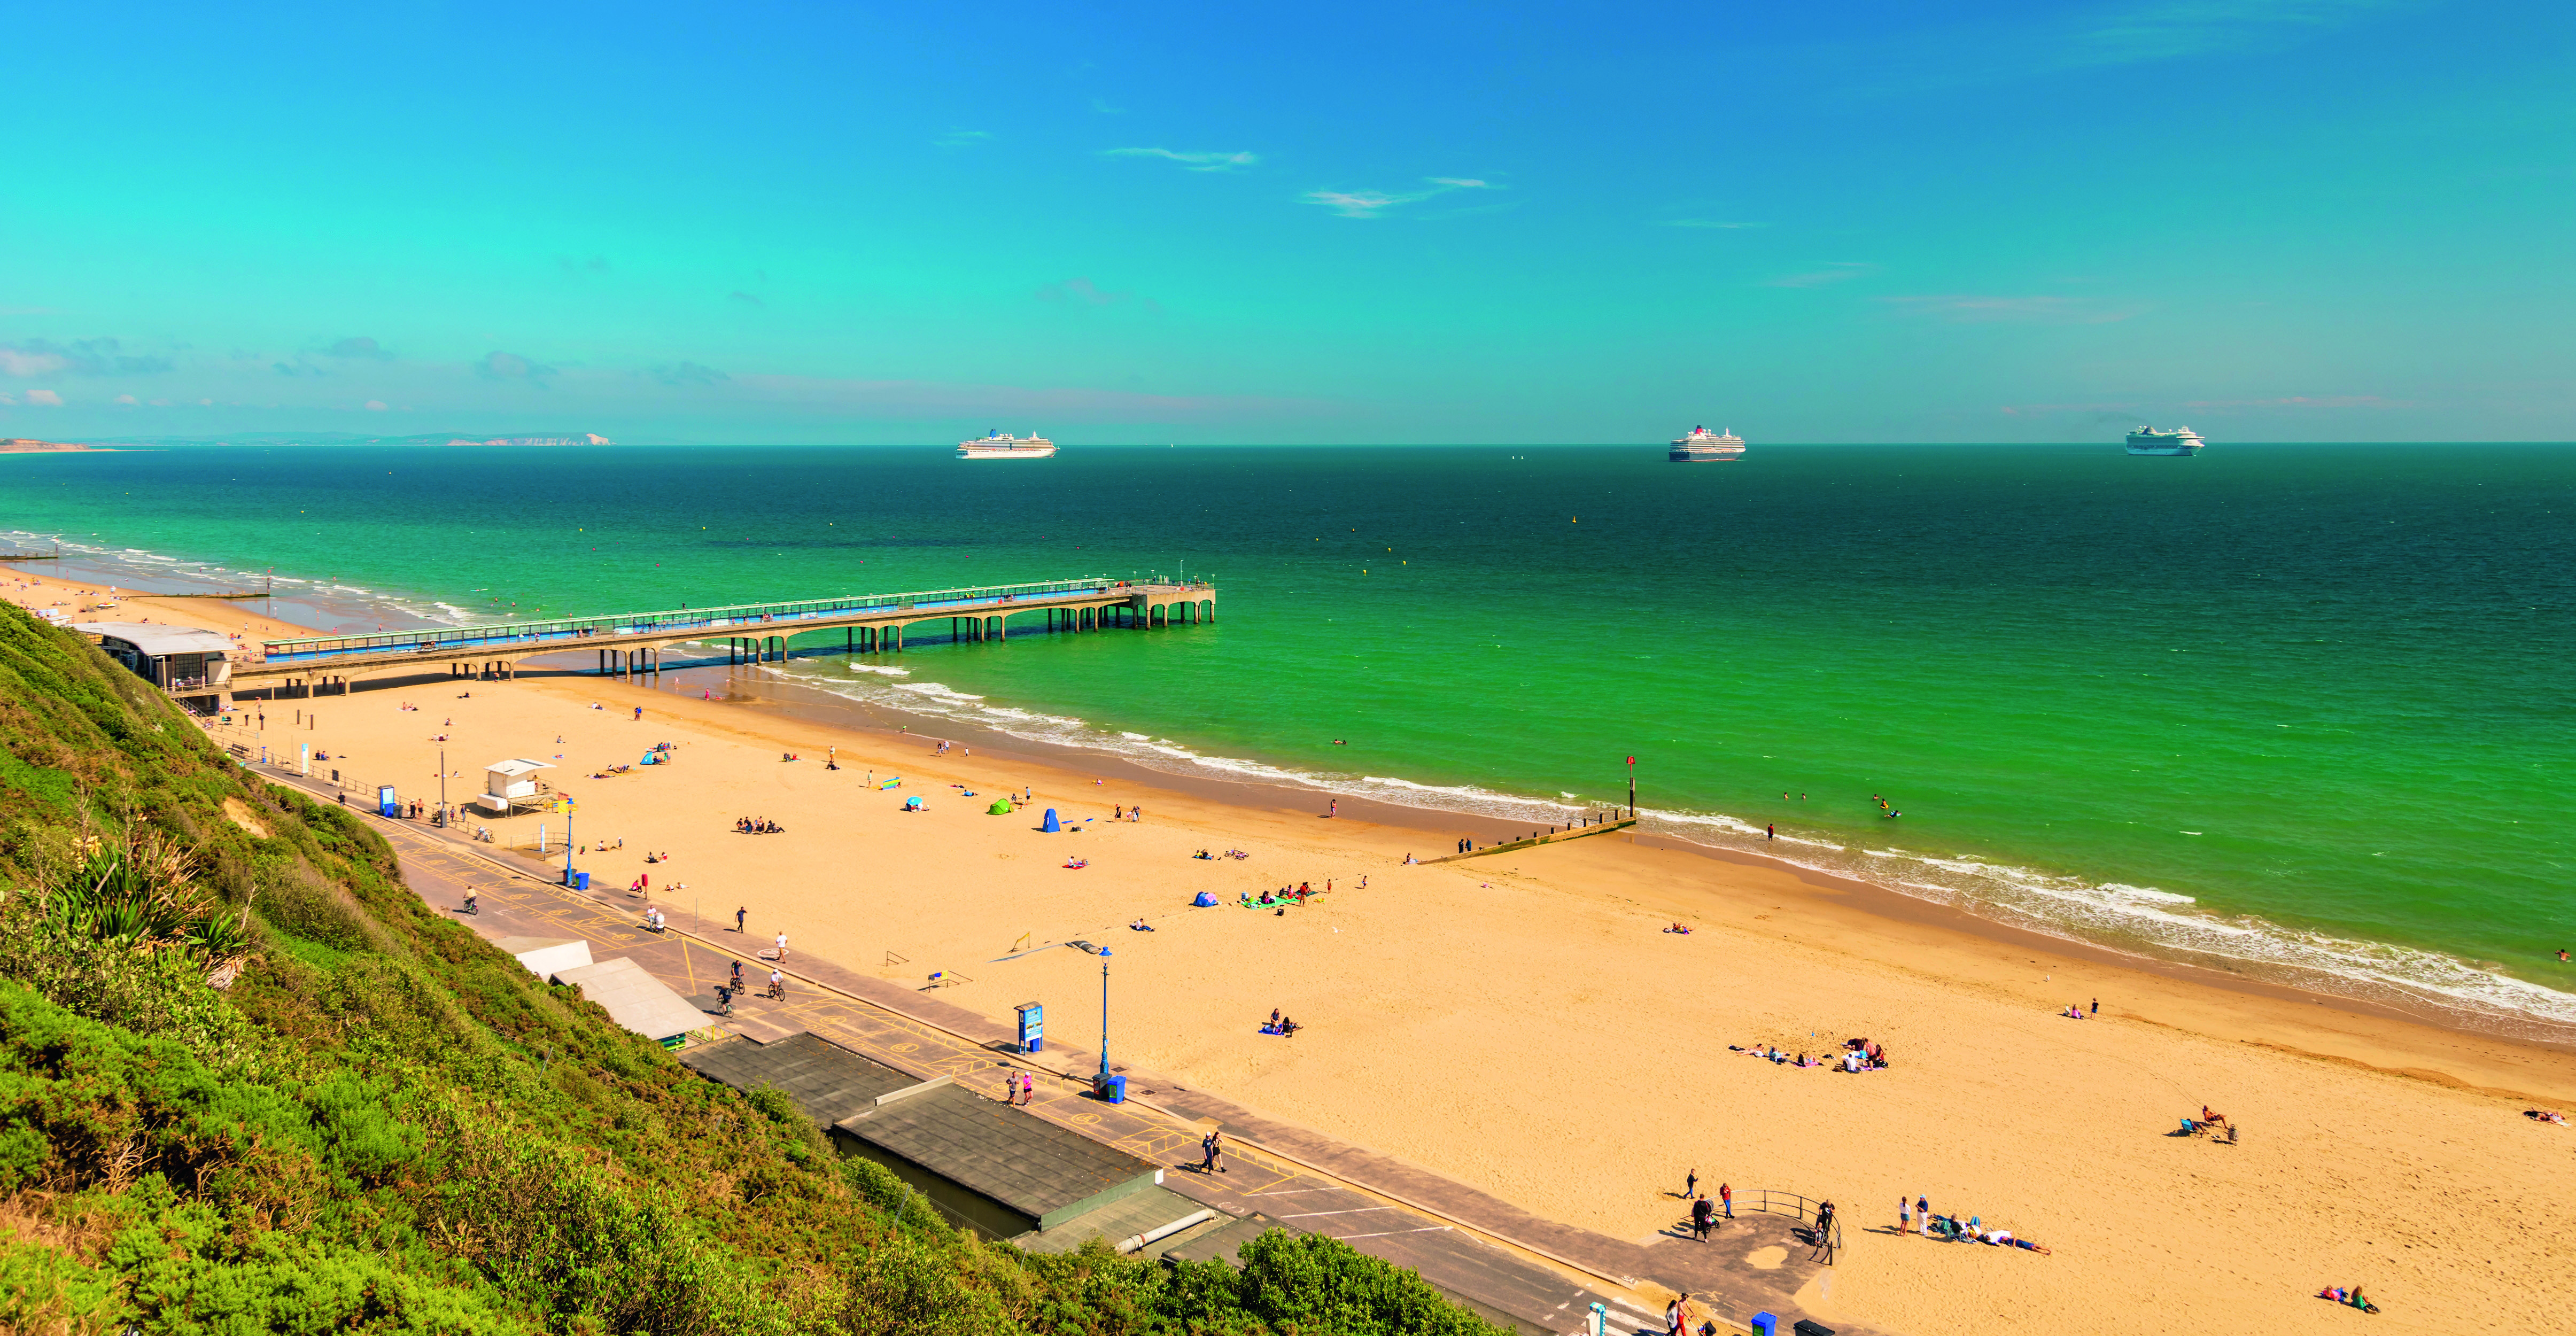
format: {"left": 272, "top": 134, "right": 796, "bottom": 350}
{"left": 10, "top": 558, "right": 2576, "bottom": 1333}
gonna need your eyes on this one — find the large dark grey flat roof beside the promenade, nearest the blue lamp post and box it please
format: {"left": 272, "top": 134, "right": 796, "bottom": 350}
{"left": 832, "top": 1076, "right": 1162, "bottom": 1238}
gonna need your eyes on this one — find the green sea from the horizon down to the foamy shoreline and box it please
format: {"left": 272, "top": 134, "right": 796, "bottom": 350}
{"left": 0, "top": 443, "right": 2576, "bottom": 1027}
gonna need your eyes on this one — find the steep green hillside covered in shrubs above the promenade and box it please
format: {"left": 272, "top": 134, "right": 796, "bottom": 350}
{"left": 0, "top": 608, "right": 1494, "bottom": 1336}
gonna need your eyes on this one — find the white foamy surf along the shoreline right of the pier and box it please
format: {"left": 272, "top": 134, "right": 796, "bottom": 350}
{"left": 752, "top": 654, "right": 2576, "bottom": 1037}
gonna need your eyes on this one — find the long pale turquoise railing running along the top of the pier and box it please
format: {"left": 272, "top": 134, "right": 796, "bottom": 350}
{"left": 260, "top": 577, "right": 1180, "bottom": 664}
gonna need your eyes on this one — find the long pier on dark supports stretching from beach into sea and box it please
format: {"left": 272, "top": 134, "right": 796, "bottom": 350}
{"left": 232, "top": 577, "right": 1216, "bottom": 697}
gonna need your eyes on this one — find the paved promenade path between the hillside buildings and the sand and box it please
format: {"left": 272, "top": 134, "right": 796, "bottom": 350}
{"left": 250, "top": 765, "right": 1883, "bottom": 1336}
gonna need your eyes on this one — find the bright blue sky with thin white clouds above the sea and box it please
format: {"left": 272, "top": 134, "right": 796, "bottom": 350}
{"left": 0, "top": 0, "right": 2576, "bottom": 443}
